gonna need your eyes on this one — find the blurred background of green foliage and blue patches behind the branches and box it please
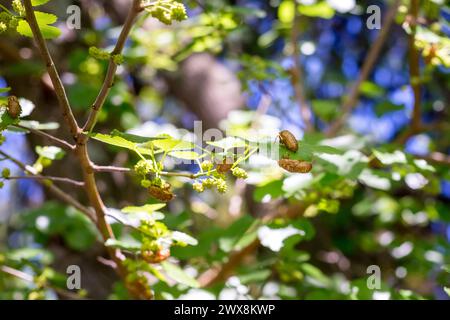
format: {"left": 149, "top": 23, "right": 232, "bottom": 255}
{"left": 0, "top": 0, "right": 450, "bottom": 299}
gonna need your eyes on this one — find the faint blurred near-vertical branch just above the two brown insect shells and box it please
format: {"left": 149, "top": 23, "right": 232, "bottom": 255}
{"left": 290, "top": 10, "right": 313, "bottom": 131}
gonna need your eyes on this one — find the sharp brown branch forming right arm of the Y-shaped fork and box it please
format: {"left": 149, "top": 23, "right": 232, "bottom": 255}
{"left": 83, "top": 0, "right": 142, "bottom": 136}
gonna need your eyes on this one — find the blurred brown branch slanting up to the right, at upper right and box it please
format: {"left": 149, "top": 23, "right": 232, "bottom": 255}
{"left": 327, "top": 0, "right": 401, "bottom": 137}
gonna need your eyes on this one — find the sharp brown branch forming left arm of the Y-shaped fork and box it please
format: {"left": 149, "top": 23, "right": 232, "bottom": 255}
{"left": 23, "top": 0, "right": 80, "bottom": 140}
